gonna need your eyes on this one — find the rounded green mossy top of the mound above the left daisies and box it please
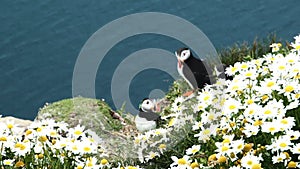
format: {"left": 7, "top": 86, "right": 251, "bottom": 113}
{"left": 36, "top": 97, "right": 133, "bottom": 131}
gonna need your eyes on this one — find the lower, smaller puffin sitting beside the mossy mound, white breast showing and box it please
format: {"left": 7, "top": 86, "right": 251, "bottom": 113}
{"left": 135, "top": 98, "right": 160, "bottom": 132}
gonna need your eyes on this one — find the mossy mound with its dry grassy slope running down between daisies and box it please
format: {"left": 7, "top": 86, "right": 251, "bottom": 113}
{"left": 36, "top": 97, "right": 137, "bottom": 161}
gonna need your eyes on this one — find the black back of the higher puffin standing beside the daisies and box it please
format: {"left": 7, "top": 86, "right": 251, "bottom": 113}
{"left": 183, "top": 53, "right": 212, "bottom": 89}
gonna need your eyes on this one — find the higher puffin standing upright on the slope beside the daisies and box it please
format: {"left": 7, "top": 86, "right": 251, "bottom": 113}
{"left": 175, "top": 47, "right": 213, "bottom": 92}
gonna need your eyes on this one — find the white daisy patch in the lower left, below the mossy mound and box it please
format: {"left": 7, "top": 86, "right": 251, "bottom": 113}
{"left": 0, "top": 117, "right": 109, "bottom": 169}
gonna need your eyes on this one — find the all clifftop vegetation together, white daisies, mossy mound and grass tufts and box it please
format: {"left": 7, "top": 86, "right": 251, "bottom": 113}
{"left": 0, "top": 34, "right": 300, "bottom": 169}
